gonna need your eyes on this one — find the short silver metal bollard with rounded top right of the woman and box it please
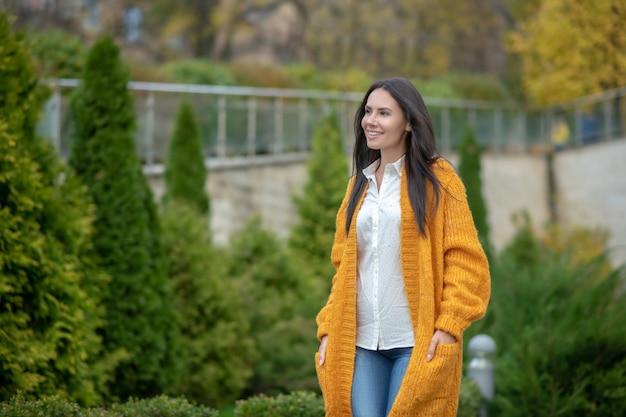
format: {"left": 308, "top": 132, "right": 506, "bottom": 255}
{"left": 467, "top": 334, "right": 496, "bottom": 417}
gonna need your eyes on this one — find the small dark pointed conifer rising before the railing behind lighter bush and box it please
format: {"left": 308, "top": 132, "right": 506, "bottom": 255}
{"left": 163, "top": 100, "right": 209, "bottom": 214}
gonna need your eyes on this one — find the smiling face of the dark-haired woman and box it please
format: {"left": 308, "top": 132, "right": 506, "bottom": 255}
{"left": 361, "top": 88, "right": 411, "bottom": 163}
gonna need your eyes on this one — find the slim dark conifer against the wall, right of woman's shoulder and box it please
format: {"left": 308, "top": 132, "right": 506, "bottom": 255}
{"left": 459, "top": 128, "right": 490, "bottom": 252}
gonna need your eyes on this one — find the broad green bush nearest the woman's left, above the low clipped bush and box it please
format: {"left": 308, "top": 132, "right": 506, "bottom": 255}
{"left": 226, "top": 217, "right": 318, "bottom": 394}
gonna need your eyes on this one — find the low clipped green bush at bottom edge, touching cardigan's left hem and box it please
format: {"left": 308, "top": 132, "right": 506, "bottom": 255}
{"left": 235, "top": 391, "right": 325, "bottom": 417}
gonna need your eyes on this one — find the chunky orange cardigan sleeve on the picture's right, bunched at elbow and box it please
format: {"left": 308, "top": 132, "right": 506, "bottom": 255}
{"left": 435, "top": 172, "right": 491, "bottom": 339}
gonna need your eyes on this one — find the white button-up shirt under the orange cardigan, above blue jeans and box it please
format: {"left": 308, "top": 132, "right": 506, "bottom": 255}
{"left": 356, "top": 157, "right": 414, "bottom": 350}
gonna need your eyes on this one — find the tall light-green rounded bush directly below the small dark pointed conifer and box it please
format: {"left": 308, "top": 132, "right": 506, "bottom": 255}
{"left": 161, "top": 201, "right": 257, "bottom": 406}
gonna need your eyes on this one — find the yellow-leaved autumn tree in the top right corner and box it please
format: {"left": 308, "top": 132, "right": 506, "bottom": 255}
{"left": 511, "top": 0, "right": 626, "bottom": 105}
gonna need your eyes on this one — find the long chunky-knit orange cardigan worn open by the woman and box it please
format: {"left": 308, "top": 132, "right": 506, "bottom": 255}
{"left": 315, "top": 159, "right": 490, "bottom": 417}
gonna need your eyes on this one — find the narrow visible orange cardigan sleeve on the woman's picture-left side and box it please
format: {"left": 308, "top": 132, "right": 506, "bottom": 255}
{"left": 316, "top": 177, "right": 354, "bottom": 341}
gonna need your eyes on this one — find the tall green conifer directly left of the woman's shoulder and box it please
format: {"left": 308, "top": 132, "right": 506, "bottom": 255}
{"left": 289, "top": 113, "right": 349, "bottom": 293}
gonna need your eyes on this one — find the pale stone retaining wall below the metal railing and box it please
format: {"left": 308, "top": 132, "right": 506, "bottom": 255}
{"left": 147, "top": 140, "right": 626, "bottom": 264}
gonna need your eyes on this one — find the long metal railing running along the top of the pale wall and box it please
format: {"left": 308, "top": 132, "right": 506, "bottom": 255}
{"left": 38, "top": 79, "right": 626, "bottom": 166}
